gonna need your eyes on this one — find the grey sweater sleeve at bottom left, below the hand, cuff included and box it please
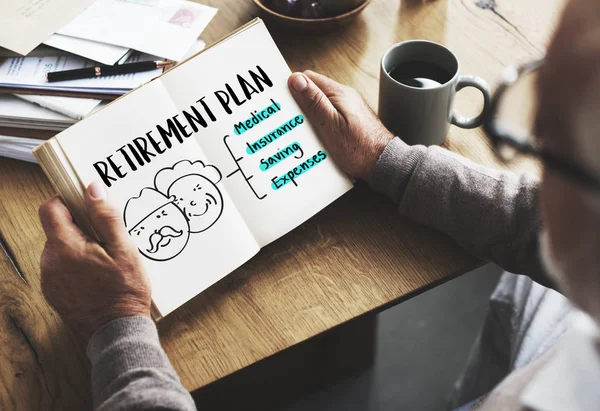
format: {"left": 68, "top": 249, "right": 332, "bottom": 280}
{"left": 87, "top": 317, "right": 196, "bottom": 411}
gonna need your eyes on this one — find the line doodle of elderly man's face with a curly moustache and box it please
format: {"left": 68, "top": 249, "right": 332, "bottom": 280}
{"left": 123, "top": 187, "right": 190, "bottom": 261}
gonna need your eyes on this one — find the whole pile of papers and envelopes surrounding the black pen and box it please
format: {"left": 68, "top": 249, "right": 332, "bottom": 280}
{"left": 0, "top": 0, "right": 217, "bottom": 161}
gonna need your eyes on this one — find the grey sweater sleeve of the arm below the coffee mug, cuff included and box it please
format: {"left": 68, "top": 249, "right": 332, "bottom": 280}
{"left": 369, "top": 138, "right": 552, "bottom": 286}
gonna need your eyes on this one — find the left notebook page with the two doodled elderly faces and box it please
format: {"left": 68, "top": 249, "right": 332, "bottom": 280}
{"left": 56, "top": 81, "right": 259, "bottom": 316}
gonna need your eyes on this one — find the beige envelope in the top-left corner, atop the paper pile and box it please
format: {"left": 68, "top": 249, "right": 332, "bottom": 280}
{"left": 0, "top": 0, "right": 93, "bottom": 54}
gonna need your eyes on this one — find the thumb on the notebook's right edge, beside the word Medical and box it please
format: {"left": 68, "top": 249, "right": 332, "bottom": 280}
{"left": 288, "top": 73, "right": 336, "bottom": 123}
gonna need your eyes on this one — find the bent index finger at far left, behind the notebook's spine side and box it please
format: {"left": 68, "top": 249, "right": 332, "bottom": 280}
{"left": 39, "top": 196, "right": 83, "bottom": 242}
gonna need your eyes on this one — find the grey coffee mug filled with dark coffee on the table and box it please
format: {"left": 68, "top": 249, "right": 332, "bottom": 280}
{"left": 379, "top": 40, "right": 491, "bottom": 146}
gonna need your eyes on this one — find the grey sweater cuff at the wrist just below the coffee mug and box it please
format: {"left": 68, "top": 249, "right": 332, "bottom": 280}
{"left": 369, "top": 137, "right": 427, "bottom": 204}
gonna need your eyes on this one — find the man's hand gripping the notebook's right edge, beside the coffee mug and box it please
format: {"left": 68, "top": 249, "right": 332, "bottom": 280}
{"left": 288, "top": 71, "right": 394, "bottom": 180}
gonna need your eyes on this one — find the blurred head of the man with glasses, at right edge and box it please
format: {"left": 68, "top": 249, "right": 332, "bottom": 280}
{"left": 537, "top": 0, "right": 600, "bottom": 324}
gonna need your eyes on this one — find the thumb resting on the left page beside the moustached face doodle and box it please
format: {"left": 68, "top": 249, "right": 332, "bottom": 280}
{"left": 85, "top": 181, "right": 128, "bottom": 245}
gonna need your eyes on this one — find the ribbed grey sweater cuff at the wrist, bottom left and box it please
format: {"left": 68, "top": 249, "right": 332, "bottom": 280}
{"left": 86, "top": 316, "right": 172, "bottom": 398}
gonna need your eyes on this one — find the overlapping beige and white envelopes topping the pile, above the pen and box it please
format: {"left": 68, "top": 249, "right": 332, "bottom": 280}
{"left": 0, "top": 0, "right": 217, "bottom": 65}
